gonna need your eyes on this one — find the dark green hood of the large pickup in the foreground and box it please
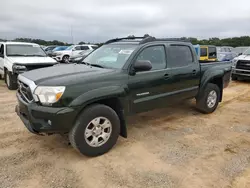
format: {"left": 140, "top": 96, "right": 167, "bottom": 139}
{"left": 22, "top": 64, "right": 115, "bottom": 86}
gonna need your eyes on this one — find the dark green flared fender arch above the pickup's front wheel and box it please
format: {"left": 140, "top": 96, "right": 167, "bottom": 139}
{"left": 69, "top": 86, "right": 126, "bottom": 107}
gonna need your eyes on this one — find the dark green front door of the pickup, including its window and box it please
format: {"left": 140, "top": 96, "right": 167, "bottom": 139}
{"left": 128, "top": 44, "right": 168, "bottom": 113}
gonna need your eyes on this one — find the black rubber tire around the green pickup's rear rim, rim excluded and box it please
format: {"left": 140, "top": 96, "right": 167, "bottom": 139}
{"left": 196, "top": 83, "right": 221, "bottom": 114}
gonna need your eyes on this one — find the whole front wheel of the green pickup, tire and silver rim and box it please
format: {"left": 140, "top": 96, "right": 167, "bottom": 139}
{"left": 69, "top": 104, "right": 120, "bottom": 157}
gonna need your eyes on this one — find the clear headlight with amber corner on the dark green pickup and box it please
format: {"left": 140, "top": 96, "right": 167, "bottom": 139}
{"left": 34, "top": 86, "right": 65, "bottom": 105}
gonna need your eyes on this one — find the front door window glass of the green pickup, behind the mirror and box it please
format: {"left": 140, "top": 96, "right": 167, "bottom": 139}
{"left": 137, "top": 46, "right": 166, "bottom": 70}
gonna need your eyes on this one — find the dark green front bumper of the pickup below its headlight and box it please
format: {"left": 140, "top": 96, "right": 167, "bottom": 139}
{"left": 15, "top": 92, "right": 79, "bottom": 134}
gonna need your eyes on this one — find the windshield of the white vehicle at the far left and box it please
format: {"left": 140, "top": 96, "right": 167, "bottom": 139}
{"left": 6, "top": 44, "right": 47, "bottom": 57}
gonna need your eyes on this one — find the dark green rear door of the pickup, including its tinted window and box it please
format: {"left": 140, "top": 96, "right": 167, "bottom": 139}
{"left": 166, "top": 44, "right": 200, "bottom": 100}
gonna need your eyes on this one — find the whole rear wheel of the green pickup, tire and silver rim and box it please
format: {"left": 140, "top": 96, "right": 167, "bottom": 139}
{"left": 196, "top": 83, "right": 220, "bottom": 114}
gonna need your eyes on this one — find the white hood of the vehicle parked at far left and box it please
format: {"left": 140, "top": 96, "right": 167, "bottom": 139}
{"left": 8, "top": 57, "right": 57, "bottom": 64}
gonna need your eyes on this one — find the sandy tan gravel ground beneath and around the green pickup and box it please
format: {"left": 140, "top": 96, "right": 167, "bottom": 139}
{"left": 0, "top": 81, "right": 250, "bottom": 188}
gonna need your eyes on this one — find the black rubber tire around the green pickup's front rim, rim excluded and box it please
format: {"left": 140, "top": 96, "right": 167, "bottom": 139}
{"left": 69, "top": 104, "right": 120, "bottom": 157}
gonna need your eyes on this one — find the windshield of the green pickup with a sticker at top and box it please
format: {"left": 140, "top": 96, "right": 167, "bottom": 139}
{"left": 84, "top": 44, "right": 137, "bottom": 69}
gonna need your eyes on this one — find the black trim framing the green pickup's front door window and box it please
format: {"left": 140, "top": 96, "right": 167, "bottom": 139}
{"left": 132, "top": 43, "right": 167, "bottom": 74}
